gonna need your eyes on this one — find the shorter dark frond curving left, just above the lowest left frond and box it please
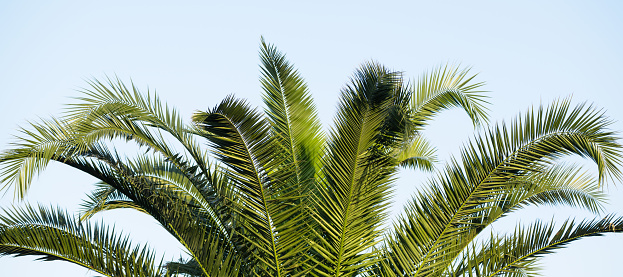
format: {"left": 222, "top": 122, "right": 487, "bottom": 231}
{"left": 75, "top": 152, "right": 239, "bottom": 276}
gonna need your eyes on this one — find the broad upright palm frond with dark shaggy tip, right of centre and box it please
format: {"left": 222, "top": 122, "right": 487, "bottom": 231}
{"left": 313, "top": 63, "right": 402, "bottom": 276}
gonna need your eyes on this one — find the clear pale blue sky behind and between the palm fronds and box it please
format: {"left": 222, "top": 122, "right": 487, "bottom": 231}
{"left": 0, "top": 0, "right": 623, "bottom": 276}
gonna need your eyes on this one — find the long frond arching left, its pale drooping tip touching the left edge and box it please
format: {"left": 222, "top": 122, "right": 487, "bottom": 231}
{"left": 2, "top": 117, "right": 239, "bottom": 276}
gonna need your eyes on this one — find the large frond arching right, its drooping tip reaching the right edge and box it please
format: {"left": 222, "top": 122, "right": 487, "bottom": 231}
{"left": 388, "top": 100, "right": 621, "bottom": 276}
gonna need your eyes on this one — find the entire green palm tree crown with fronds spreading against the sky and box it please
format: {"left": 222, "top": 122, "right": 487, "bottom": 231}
{"left": 0, "top": 40, "right": 623, "bottom": 276}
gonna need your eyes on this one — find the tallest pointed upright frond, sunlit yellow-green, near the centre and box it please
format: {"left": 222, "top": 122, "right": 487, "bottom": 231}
{"left": 260, "top": 39, "right": 324, "bottom": 275}
